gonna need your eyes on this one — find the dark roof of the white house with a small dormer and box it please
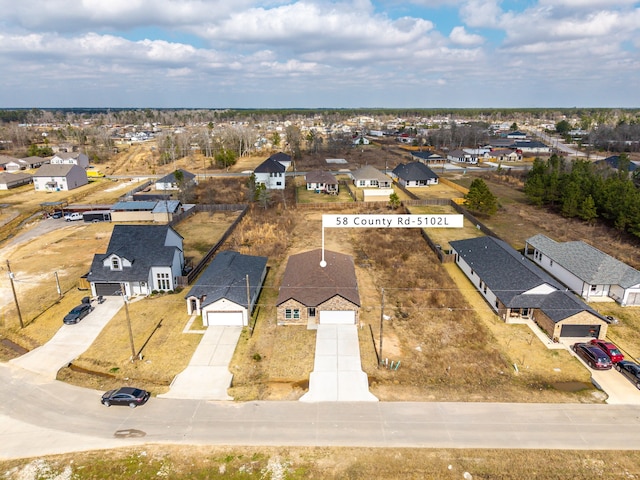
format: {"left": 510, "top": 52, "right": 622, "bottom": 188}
{"left": 87, "top": 225, "right": 182, "bottom": 282}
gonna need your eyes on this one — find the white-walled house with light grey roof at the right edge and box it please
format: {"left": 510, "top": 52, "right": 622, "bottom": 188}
{"left": 525, "top": 234, "right": 640, "bottom": 306}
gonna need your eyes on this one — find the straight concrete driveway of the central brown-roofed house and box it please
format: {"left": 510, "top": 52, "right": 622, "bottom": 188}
{"left": 300, "top": 325, "right": 378, "bottom": 402}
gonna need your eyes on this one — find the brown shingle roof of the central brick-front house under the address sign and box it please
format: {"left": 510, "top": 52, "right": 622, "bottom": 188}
{"left": 276, "top": 249, "right": 360, "bottom": 307}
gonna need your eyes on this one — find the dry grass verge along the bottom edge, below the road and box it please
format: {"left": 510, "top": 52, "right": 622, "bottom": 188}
{"left": 5, "top": 445, "right": 640, "bottom": 480}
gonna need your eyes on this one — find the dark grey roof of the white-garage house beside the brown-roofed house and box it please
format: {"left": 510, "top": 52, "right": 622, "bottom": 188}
{"left": 185, "top": 250, "right": 267, "bottom": 308}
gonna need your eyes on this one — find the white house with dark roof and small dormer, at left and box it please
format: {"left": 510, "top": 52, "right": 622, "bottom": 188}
{"left": 87, "top": 225, "right": 184, "bottom": 296}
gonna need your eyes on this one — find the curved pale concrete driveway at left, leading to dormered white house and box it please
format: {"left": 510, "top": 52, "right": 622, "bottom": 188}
{"left": 10, "top": 297, "right": 123, "bottom": 380}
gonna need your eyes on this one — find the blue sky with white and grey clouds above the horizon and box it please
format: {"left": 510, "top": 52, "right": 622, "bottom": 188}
{"left": 0, "top": 0, "right": 640, "bottom": 108}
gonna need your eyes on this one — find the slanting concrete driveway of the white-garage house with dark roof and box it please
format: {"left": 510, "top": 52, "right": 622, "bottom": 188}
{"left": 158, "top": 326, "right": 242, "bottom": 400}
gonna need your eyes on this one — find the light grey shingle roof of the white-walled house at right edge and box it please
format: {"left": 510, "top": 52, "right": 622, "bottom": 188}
{"left": 527, "top": 234, "right": 640, "bottom": 288}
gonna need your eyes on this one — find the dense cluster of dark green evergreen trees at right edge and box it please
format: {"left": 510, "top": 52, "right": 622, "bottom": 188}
{"left": 524, "top": 154, "right": 640, "bottom": 237}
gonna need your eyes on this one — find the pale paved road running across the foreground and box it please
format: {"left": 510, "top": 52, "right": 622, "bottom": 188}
{"left": 0, "top": 364, "right": 640, "bottom": 459}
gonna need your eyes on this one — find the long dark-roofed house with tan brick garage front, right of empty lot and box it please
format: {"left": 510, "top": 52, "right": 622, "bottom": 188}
{"left": 449, "top": 237, "right": 608, "bottom": 340}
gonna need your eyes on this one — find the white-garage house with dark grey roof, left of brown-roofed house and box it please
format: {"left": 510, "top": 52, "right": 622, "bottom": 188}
{"left": 185, "top": 250, "right": 267, "bottom": 327}
